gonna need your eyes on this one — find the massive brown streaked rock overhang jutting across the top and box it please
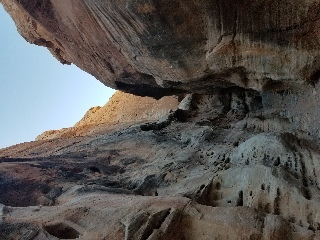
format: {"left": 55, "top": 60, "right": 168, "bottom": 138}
{"left": 2, "top": 0, "right": 320, "bottom": 98}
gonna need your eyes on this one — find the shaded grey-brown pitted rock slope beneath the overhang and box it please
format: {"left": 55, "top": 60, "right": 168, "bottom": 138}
{"left": 0, "top": 85, "right": 320, "bottom": 240}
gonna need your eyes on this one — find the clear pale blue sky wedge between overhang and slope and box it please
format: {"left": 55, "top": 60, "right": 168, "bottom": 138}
{"left": 0, "top": 4, "right": 114, "bottom": 148}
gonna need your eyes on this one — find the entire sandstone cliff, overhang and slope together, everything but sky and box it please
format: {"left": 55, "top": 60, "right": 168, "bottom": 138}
{"left": 0, "top": 0, "right": 320, "bottom": 240}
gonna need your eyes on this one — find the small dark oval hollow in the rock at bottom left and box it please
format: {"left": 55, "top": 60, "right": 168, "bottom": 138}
{"left": 44, "top": 223, "right": 80, "bottom": 239}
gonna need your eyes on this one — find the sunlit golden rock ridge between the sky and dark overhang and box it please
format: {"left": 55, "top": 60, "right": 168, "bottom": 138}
{"left": 36, "top": 91, "right": 178, "bottom": 140}
